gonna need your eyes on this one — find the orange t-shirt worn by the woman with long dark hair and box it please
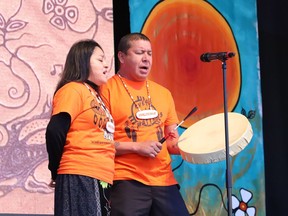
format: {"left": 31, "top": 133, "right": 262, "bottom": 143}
{"left": 53, "top": 82, "right": 115, "bottom": 184}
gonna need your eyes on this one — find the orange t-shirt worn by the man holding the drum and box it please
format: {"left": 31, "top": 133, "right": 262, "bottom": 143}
{"left": 101, "top": 75, "right": 178, "bottom": 186}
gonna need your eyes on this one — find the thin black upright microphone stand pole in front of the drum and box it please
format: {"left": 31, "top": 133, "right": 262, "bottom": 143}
{"left": 221, "top": 58, "right": 232, "bottom": 216}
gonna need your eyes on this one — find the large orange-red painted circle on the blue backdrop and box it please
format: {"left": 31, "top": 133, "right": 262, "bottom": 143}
{"left": 141, "top": 0, "right": 241, "bottom": 128}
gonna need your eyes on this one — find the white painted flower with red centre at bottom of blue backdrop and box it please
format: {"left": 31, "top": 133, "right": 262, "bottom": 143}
{"left": 232, "top": 188, "right": 256, "bottom": 216}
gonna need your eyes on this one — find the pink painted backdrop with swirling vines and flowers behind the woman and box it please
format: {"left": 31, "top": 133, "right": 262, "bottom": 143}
{"left": 0, "top": 0, "right": 114, "bottom": 214}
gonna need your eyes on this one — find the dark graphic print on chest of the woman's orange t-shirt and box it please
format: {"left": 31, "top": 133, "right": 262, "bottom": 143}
{"left": 90, "top": 99, "right": 114, "bottom": 140}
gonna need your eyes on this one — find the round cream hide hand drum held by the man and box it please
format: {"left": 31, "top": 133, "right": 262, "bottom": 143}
{"left": 178, "top": 112, "right": 253, "bottom": 164}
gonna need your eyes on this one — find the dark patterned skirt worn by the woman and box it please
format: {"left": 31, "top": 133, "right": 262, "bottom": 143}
{"left": 54, "top": 175, "right": 111, "bottom": 216}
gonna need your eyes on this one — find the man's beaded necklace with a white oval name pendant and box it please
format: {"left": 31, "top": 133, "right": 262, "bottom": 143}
{"left": 117, "top": 73, "right": 158, "bottom": 119}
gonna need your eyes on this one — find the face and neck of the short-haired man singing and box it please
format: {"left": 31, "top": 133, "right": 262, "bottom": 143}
{"left": 118, "top": 40, "right": 152, "bottom": 81}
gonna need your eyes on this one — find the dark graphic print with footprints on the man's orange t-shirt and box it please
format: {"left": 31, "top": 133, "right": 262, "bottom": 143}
{"left": 125, "top": 96, "right": 163, "bottom": 142}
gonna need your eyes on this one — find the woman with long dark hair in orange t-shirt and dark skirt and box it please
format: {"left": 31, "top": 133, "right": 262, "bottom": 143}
{"left": 46, "top": 40, "right": 115, "bottom": 216}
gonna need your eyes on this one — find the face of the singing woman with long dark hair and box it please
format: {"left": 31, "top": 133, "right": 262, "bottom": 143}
{"left": 88, "top": 47, "right": 108, "bottom": 86}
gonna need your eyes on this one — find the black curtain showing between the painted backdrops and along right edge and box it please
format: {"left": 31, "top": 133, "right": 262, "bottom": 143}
{"left": 113, "top": 0, "right": 288, "bottom": 216}
